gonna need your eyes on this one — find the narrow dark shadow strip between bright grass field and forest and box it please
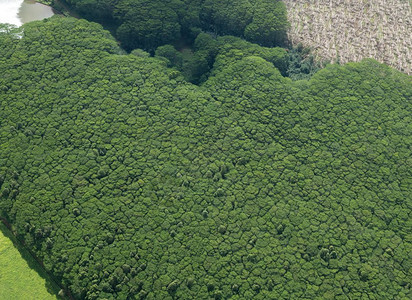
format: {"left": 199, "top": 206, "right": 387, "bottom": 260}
{"left": 0, "top": 220, "right": 67, "bottom": 299}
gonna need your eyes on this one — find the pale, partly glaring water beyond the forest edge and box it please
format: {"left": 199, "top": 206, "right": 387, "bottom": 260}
{"left": 0, "top": 0, "right": 54, "bottom": 26}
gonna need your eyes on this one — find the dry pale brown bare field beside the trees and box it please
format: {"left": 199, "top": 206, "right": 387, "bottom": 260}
{"left": 284, "top": 0, "right": 412, "bottom": 74}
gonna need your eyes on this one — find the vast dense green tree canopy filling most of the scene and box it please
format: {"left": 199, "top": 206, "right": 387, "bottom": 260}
{"left": 0, "top": 18, "right": 412, "bottom": 299}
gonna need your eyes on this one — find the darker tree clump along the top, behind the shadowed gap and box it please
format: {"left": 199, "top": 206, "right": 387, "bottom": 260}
{"left": 62, "top": 0, "right": 288, "bottom": 51}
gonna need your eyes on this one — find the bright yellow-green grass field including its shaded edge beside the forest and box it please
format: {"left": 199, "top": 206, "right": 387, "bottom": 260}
{"left": 0, "top": 221, "right": 59, "bottom": 300}
